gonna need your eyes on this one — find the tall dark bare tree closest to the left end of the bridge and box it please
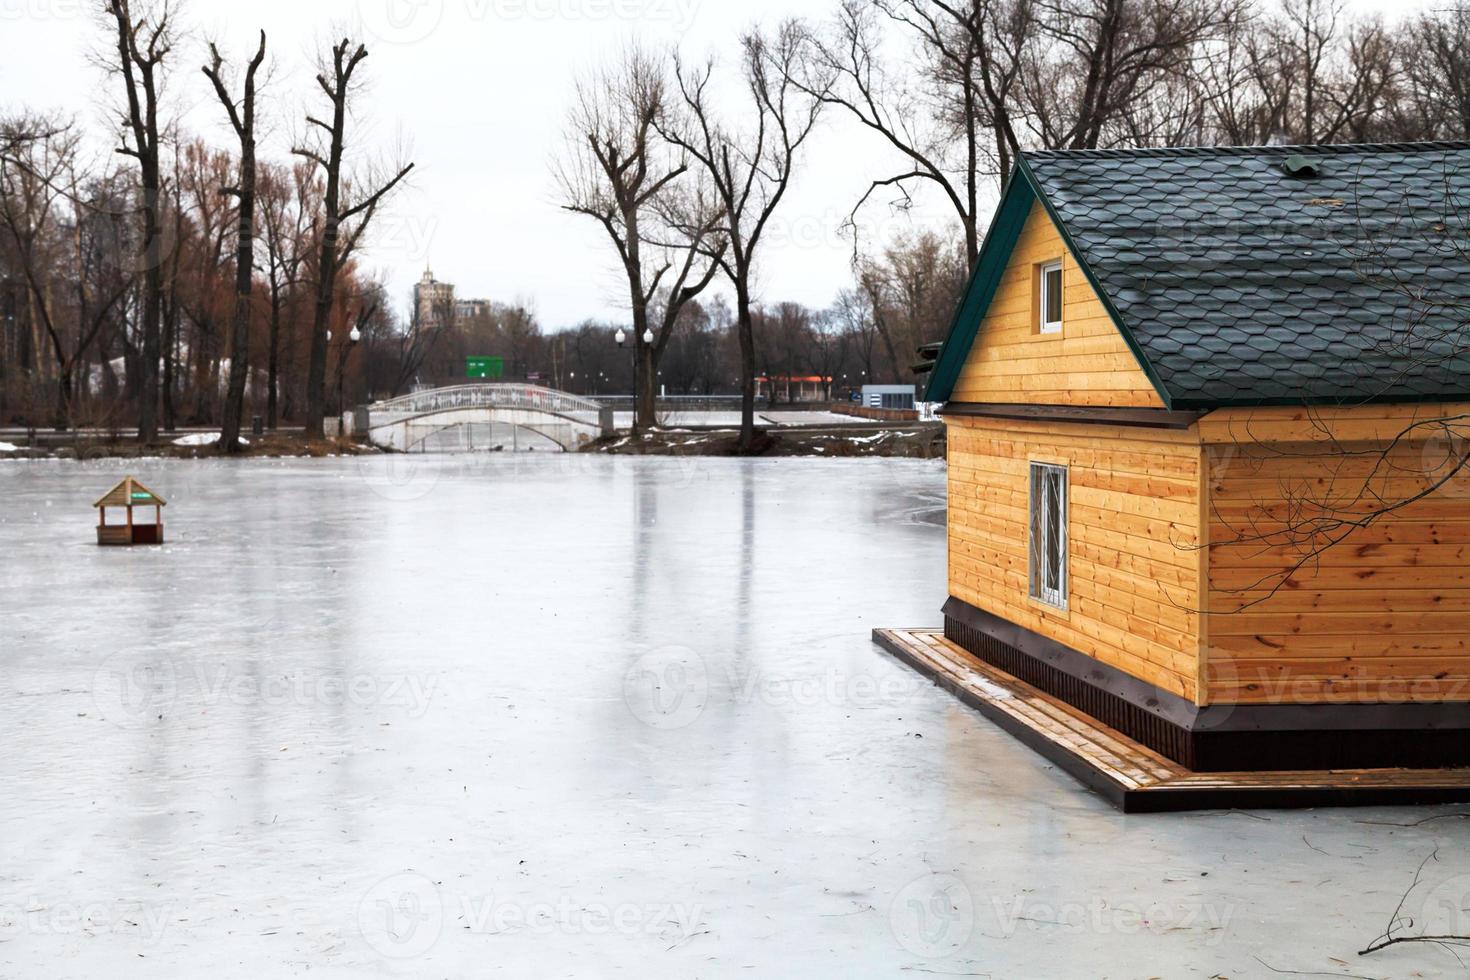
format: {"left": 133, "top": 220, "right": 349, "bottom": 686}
{"left": 291, "top": 38, "right": 413, "bottom": 439}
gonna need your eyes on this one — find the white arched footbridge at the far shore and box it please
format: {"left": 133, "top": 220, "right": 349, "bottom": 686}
{"left": 366, "top": 385, "right": 613, "bottom": 453}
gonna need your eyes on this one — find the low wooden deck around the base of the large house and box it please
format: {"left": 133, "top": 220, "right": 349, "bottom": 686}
{"left": 873, "top": 629, "right": 1470, "bottom": 813}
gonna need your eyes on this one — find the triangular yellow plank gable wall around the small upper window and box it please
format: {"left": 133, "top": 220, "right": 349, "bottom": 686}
{"left": 950, "top": 204, "right": 1164, "bottom": 408}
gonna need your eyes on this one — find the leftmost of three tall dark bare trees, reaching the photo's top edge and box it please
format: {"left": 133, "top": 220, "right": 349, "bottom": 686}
{"left": 103, "top": 0, "right": 173, "bottom": 442}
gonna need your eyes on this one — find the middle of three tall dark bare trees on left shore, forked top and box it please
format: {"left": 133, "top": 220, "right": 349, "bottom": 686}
{"left": 203, "top": 31, "right": 266, "bottom": 453}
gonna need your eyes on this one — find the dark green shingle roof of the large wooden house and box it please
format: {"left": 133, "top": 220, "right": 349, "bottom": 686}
{"left": 928, "top": 143, "right": 1470, "bottom": 408}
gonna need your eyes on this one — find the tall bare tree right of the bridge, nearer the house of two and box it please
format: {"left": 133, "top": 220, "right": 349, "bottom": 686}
{"left": 660, "top": 22, "right": 823, "bottom": 453}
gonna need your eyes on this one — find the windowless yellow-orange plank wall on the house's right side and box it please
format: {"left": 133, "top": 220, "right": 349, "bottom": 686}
{"left": 1201, "top": 431, "right": 1470, "bottom": 704}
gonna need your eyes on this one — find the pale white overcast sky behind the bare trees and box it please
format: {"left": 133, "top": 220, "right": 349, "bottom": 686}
{"left": 0, "top": 0, "right": 1417, "bottom": 329}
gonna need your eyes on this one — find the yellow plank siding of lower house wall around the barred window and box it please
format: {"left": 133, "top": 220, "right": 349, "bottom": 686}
{"left": 947, "top": 416, "right": 1202, "bottom": 699}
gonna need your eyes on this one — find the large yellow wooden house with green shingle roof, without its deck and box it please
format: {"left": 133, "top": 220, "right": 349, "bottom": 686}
{"left": 926, "top": 143, "right": 1470, "bottom": 771}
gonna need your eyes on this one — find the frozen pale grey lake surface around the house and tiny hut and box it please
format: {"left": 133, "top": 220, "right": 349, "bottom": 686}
{"left": 0, "top": 453, "right": 1470, "bottom": 980}
